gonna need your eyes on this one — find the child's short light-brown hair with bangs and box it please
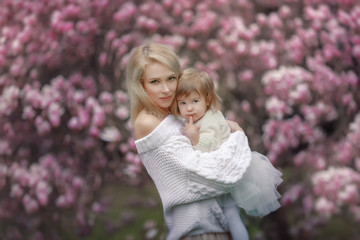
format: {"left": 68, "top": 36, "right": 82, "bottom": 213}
{"left": 171, "top": 68, "right": 221, "bottom": 116}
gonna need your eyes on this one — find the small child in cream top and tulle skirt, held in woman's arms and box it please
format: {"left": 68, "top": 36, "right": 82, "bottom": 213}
{"left": 172, "top": 68, "right": 282, "bottom": 240}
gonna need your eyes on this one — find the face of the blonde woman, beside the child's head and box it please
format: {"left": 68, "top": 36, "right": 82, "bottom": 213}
{"left": 143, "top": 62, "right": 177, "bottom": 112}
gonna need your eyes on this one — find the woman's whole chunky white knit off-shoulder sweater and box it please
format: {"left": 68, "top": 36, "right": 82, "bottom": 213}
{"left": 135, "top": 115, "right": 251, "bottom": 240}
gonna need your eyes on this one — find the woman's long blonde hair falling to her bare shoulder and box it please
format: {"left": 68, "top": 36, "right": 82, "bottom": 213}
{"left": 126, "top": 43, "right": 181, "bottom": 122}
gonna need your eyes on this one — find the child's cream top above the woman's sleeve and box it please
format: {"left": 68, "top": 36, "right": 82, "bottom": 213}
{"left": 194, "top": 110, "right": 230, "bottom": 152}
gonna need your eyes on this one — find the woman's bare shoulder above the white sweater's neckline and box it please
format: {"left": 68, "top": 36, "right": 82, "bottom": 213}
{"left": 134, "top": 111, "right": 161, "bottom": 139}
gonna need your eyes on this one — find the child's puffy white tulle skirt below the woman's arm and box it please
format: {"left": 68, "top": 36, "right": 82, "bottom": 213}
{"left": 231, "top": 152, "right": 283, "bottom": 217}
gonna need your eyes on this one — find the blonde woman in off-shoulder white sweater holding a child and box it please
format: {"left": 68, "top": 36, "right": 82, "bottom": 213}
{"left": 127, "top": 43, "right": 251, "bottom": 240}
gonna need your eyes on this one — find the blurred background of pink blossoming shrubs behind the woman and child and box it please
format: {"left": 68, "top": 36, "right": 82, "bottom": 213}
{"left": 0, "top": 0, "right": 360, "bottom": 240}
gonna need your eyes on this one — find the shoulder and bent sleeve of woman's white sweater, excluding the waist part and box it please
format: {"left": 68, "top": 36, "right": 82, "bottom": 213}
{"left": 136, "top": 115, "right": 251, "bottom": 207}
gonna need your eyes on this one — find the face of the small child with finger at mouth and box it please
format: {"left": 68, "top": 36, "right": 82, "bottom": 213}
{"left": 176, "top": 92, "right": 209, "bottom": 122}
